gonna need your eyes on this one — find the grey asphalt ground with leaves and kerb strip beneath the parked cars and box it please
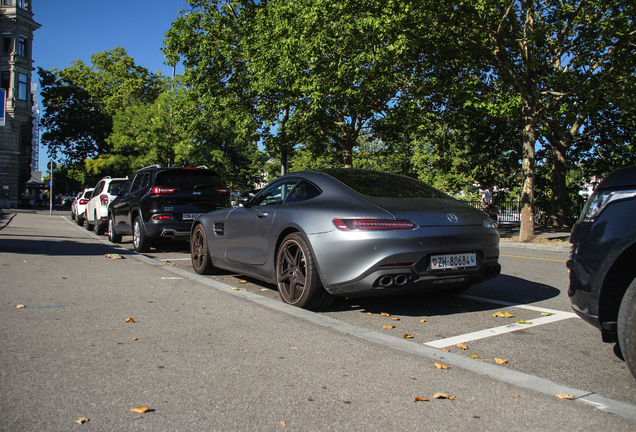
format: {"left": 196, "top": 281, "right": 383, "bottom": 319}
{"left": 0, "top": 211, "right": 636, "bottom": 431}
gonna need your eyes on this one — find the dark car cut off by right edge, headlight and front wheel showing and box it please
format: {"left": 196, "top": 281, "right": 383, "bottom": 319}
{"left": 568, "top": 166, "right": 636, "bottom": 377}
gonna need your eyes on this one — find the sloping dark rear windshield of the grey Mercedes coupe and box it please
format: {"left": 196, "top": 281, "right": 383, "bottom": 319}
{"left": 323, "top": 169, "right": 450, "bottom": 198}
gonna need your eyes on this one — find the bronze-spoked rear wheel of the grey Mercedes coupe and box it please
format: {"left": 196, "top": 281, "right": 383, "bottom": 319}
{"left": 276, "top": 233, "right": 334, "bottom": 310}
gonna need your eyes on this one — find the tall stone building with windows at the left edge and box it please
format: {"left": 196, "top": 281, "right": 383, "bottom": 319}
{"left": 0, "top": 0, "right": 40, "bottom": 208}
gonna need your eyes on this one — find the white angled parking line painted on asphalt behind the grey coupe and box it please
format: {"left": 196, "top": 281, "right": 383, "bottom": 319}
{"left": 424, "top": 295, "right": 578, "bottom": 348}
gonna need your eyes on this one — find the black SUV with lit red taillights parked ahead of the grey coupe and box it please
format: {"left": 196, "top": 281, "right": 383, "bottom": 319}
{"left": 108, "top": 165, "right": 230, "bottom": 252}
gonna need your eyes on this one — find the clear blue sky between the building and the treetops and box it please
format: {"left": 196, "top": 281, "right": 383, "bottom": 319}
{"left": 31, "top": 0, "right": 189, "bottom": 167}
